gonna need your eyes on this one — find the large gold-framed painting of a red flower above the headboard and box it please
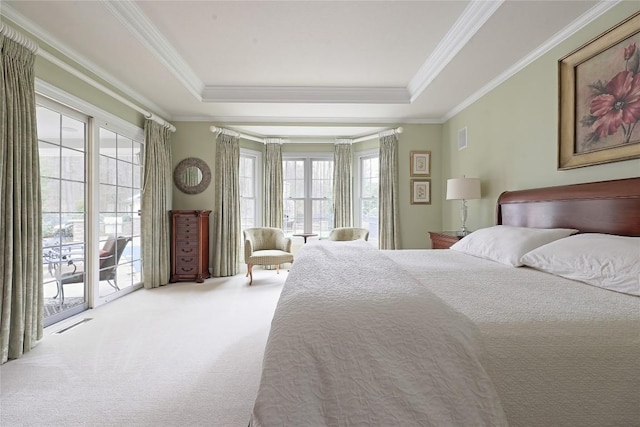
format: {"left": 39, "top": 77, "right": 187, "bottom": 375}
{"left": 558, "top": 13, "right": 640, "bottom": 170}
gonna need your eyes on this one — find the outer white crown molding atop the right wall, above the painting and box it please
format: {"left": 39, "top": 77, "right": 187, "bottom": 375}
{"left": 442, "top": 0, "right": 622, "bottom": 123}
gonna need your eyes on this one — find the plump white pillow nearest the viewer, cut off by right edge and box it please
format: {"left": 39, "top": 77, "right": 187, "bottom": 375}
{"left": 522, "top": 233, "right": 640, "bottom": 295}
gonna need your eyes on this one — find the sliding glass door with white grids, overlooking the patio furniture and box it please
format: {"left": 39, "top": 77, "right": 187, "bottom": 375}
{"left": 37, "top": 97, "right": 144, "bottom": 326}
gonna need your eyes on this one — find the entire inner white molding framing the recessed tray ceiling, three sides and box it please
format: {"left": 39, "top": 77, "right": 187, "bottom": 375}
{"left": 97, "top": 0, "right": 492, "bottom": 104}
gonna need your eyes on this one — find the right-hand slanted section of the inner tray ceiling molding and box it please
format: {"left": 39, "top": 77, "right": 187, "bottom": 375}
{"left": 407, "top": 0, "right": 504, "bottom": 102}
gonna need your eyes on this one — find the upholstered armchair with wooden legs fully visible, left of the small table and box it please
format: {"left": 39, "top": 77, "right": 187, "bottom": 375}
{"left": 242, "top": 227, "right": 293, "bottom": 285}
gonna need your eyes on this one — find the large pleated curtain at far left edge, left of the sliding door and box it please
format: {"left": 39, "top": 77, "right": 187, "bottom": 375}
{"left": 0, "top": 34, "right": 44, "bottom": 363}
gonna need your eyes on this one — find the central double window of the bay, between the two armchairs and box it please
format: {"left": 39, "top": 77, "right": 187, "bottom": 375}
{"left": 282, "top": 154, "right": 333, "bottom": 237}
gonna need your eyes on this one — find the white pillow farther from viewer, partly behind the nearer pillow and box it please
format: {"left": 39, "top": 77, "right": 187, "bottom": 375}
{"left": 451, "top": 225, "right": 578, "bottom": 267}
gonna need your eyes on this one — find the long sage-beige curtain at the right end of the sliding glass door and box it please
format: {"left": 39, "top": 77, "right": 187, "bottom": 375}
{"left": 142, "top": 119, "right": 173, "bottom": 289}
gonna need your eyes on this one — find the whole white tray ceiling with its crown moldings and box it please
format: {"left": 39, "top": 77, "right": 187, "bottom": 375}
{"left": 0, "top": 0, "right": 616, "bottom": 138}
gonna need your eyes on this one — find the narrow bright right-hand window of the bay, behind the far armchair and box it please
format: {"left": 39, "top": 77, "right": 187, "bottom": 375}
{"left": 355, "top": 150, "right": 380, "bottom": 243}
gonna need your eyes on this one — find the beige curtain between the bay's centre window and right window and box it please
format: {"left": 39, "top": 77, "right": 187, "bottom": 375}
{"left": 333, "top": 139, "right": 353, "bottom": 227}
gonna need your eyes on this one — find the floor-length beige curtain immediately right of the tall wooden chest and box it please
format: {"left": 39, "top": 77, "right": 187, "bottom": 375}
{"left": 213, "top": 133, "right": 240, "bottom": 277}
